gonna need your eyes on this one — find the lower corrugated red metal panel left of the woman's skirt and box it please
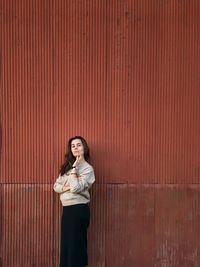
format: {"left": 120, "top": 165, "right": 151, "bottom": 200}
{"left": 2, "top": 184, "right": 53, "bottom": 267}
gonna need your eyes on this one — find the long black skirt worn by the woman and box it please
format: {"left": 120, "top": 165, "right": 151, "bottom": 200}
{"left": 60, "top": 204, "right": 90, "bottom": 267}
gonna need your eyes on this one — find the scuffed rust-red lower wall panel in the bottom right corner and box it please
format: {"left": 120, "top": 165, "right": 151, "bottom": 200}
{"left": 155, "top": 185, "right": 200, "bottom": 267}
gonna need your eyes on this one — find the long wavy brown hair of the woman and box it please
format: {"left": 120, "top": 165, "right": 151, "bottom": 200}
{"left": 60, "top": 136, "right": 90, "bottom": 175}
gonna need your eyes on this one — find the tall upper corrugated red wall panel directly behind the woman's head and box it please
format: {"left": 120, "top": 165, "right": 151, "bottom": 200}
{"left": 54, "top": 0, "right": 106, "bottom": 180}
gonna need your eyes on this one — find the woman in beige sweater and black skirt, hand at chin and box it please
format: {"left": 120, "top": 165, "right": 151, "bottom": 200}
{"left": 54, "top": 136, "right": 95, "bottom": 267}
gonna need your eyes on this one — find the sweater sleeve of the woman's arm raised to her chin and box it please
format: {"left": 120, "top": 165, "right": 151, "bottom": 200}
{"left": 68, "top": 167, "right": 95, "bottom": 193}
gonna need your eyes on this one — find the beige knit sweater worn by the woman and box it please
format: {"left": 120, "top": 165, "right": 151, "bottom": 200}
{"left": 53, "top": 161, "right": 95, "bottom": 206}
